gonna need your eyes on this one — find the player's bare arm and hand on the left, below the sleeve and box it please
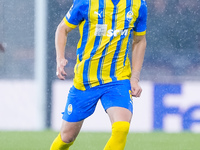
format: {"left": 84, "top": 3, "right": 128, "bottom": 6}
{"left": 55, "top": 20, "right": 72, "bottom": 80}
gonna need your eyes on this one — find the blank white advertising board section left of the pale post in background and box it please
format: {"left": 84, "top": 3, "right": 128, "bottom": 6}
{"left": 0, "top": 80, "right": 45, "bottom": 131}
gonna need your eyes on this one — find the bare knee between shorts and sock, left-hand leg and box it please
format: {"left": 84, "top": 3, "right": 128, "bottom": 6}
{"left": 60, "top": 120, "right": 84, "bottom": 143}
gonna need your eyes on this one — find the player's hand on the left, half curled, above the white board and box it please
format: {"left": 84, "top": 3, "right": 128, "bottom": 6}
{"left": 56, "top": 58, "right": 68, "bottom": 80}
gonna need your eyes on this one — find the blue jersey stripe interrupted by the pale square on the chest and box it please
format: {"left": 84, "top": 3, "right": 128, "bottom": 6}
{"left": 83, "top": 0, "right": 104, "bottom": 89}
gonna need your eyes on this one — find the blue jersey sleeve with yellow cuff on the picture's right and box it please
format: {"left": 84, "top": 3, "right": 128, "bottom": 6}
{"left": 133, "top": 0, "right": 147, "bottom": 36}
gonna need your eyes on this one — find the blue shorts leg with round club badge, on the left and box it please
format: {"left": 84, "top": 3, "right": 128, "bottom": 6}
{"left": 62, "top": 86, "right": 100, "bottom": 122}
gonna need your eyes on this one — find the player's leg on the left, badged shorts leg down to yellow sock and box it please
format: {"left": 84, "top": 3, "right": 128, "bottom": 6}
{"left": 51, "top": 86, "right": 101, "bottom": 150}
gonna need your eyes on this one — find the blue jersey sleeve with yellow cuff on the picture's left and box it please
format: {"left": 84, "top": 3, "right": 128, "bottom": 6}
{"left": 63, "top": 0, "right": 84, "bottom": 29}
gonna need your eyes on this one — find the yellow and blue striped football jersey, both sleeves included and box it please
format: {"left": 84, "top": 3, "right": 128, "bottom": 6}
{"left": 63, "top": 0, "right": 147, "bottom": 90}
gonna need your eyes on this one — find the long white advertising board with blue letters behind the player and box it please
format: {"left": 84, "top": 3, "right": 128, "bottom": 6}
{"left": 0, "top": 80, "right": 200, "bottom": 132}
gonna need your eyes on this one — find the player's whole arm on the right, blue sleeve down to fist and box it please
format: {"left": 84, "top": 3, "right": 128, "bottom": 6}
{"left": 130, "top": 0, "right": 147, "bottom": 97}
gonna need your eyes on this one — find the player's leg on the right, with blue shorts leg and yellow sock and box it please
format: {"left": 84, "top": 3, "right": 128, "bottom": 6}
{"left": 101, "top": 80, "right": 133, "bottom": 150}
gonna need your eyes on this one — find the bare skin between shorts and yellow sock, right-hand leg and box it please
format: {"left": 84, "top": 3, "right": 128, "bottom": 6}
{"left": 106, "top": 107, "right": 132, "bottom": 124}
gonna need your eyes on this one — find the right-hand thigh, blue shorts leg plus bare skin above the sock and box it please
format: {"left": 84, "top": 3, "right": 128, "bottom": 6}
{"left": 101, "top": 80, "right": 133, "bottom": 123}
